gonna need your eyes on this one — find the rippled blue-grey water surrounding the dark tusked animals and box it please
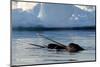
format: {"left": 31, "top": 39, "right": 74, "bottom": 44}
{"left": 12, "top": 30, "right": 95, "bottom": 65}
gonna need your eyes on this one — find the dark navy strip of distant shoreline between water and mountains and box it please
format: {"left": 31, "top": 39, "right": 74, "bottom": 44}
{"left": 12, "top": 26, "right": 96, "bottom": 31}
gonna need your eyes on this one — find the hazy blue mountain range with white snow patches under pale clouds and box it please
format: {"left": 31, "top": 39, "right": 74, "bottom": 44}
{"left": 12, "top": 3, "right": 95, "bottom": 27}
